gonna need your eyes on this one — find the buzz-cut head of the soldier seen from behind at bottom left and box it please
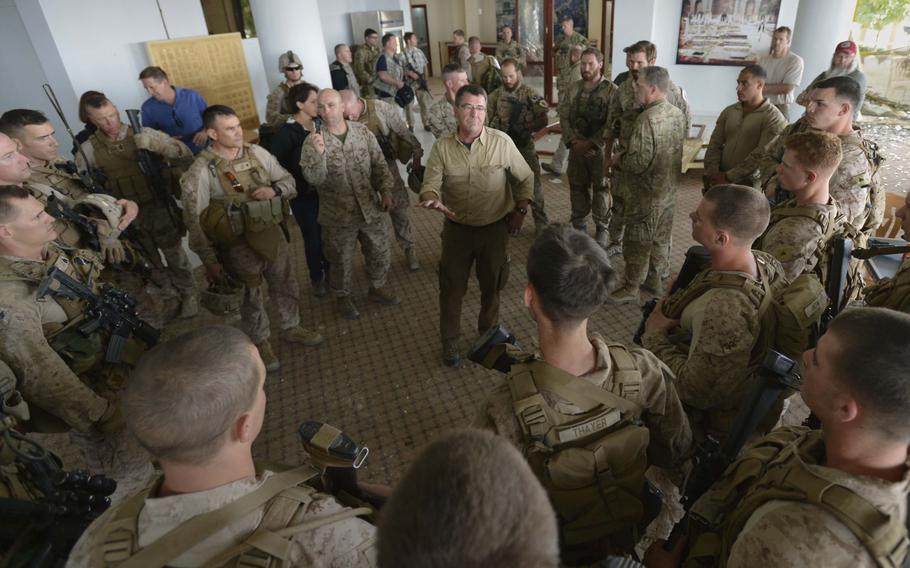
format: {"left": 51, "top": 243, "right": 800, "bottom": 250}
{"left": 123, "top": 326, "right": 266, "bottom": 472}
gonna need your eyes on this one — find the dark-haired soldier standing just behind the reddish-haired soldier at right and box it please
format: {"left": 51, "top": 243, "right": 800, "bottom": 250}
{"left": 756, "top": 77, "right": 885, "bottom": 235}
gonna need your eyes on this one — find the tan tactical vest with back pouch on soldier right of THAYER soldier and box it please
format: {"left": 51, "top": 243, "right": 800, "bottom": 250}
{"left": 661, "top": 251, "right": 828, "bottom": 433}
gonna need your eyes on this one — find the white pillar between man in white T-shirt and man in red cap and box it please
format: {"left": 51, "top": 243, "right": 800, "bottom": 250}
{"left": 790, "top": 0, "right": 856, "bottom": 93}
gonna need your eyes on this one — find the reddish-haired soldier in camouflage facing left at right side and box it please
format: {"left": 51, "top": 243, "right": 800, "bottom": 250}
{"left": 755, "top": 131, "right": 841, "bottom": 284}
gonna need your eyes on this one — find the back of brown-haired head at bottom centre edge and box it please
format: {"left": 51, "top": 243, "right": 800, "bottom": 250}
{"left": 378, "top": 430, "right": 559, "bottom": 568}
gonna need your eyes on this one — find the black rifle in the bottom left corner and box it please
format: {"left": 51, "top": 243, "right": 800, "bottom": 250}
{"left": 0, "top": 374, "right": 117, "bottom": 568}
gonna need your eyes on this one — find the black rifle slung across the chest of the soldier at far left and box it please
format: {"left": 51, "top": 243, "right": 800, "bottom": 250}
{"left": 38, "top": 266, "right": 160, "bottom": 363}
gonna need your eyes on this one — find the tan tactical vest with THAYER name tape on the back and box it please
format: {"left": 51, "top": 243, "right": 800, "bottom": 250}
{"left": 507, "top": 343, "right": 649, "bottom": 559}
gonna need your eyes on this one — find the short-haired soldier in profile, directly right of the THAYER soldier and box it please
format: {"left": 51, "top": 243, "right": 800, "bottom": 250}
{"left": 642, "top": 185, "right": 789, "bottom": 439}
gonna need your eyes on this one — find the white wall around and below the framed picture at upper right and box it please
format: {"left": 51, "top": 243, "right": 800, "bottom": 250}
{"left": 613, "top": 0, "right": 799, "bottom": 118}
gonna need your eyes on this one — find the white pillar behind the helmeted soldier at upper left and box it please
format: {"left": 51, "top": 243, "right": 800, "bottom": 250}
{"left": 250, "top": 0, "right": 332, "bottom": 89}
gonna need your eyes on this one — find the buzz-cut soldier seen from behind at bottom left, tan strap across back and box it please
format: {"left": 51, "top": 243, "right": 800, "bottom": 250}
{"left": 67, "top": 326, "right": 375, "bottom": 567}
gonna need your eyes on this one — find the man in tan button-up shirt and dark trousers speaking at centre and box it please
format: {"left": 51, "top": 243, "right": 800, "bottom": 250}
{"left": 420, "top": 85, "right": 534, "bottom": 367}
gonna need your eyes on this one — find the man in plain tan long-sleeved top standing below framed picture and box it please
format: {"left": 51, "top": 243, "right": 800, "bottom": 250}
{"left": 705, "top": 65, "right": 787, "bottom": 191}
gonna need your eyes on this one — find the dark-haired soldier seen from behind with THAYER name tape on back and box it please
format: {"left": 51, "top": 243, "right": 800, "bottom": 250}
{"left": 475, "top": 225, "right": 692, "bottom": 565}
